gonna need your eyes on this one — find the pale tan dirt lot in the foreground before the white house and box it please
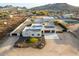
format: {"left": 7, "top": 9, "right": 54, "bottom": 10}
{"left": 2, "top": 33, "right": 79, "bottom": 56}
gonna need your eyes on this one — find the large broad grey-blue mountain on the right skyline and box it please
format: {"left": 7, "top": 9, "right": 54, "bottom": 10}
{"left": 31, "top": 3, "right": 79, "bottom": 11}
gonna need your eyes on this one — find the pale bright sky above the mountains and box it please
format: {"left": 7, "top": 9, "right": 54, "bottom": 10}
{"left": 0, "top": 0, "right": 79, "bottom": 8}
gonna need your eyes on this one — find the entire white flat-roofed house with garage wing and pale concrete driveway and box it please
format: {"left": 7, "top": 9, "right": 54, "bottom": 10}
{"left": 22, "top": 23, "right": 59, "bottom": 39}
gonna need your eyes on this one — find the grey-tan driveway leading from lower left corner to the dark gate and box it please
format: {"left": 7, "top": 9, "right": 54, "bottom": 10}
{"left": 0, "top": 36, "right": 19, "bottom": 54}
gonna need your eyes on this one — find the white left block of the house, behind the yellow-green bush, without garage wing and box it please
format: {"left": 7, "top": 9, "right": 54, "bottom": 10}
{"left": 22, "top": 24, "right": 43, "bottom": 37}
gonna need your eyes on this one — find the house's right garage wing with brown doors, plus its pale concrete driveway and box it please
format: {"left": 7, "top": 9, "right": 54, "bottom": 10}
{"left": 43, "top": 23, "right": 59, "bottom": 39}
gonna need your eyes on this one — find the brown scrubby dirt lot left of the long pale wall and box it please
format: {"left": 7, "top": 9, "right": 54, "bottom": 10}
{"left": 0, "top": 16, "right": 25, "bottom": 39}
